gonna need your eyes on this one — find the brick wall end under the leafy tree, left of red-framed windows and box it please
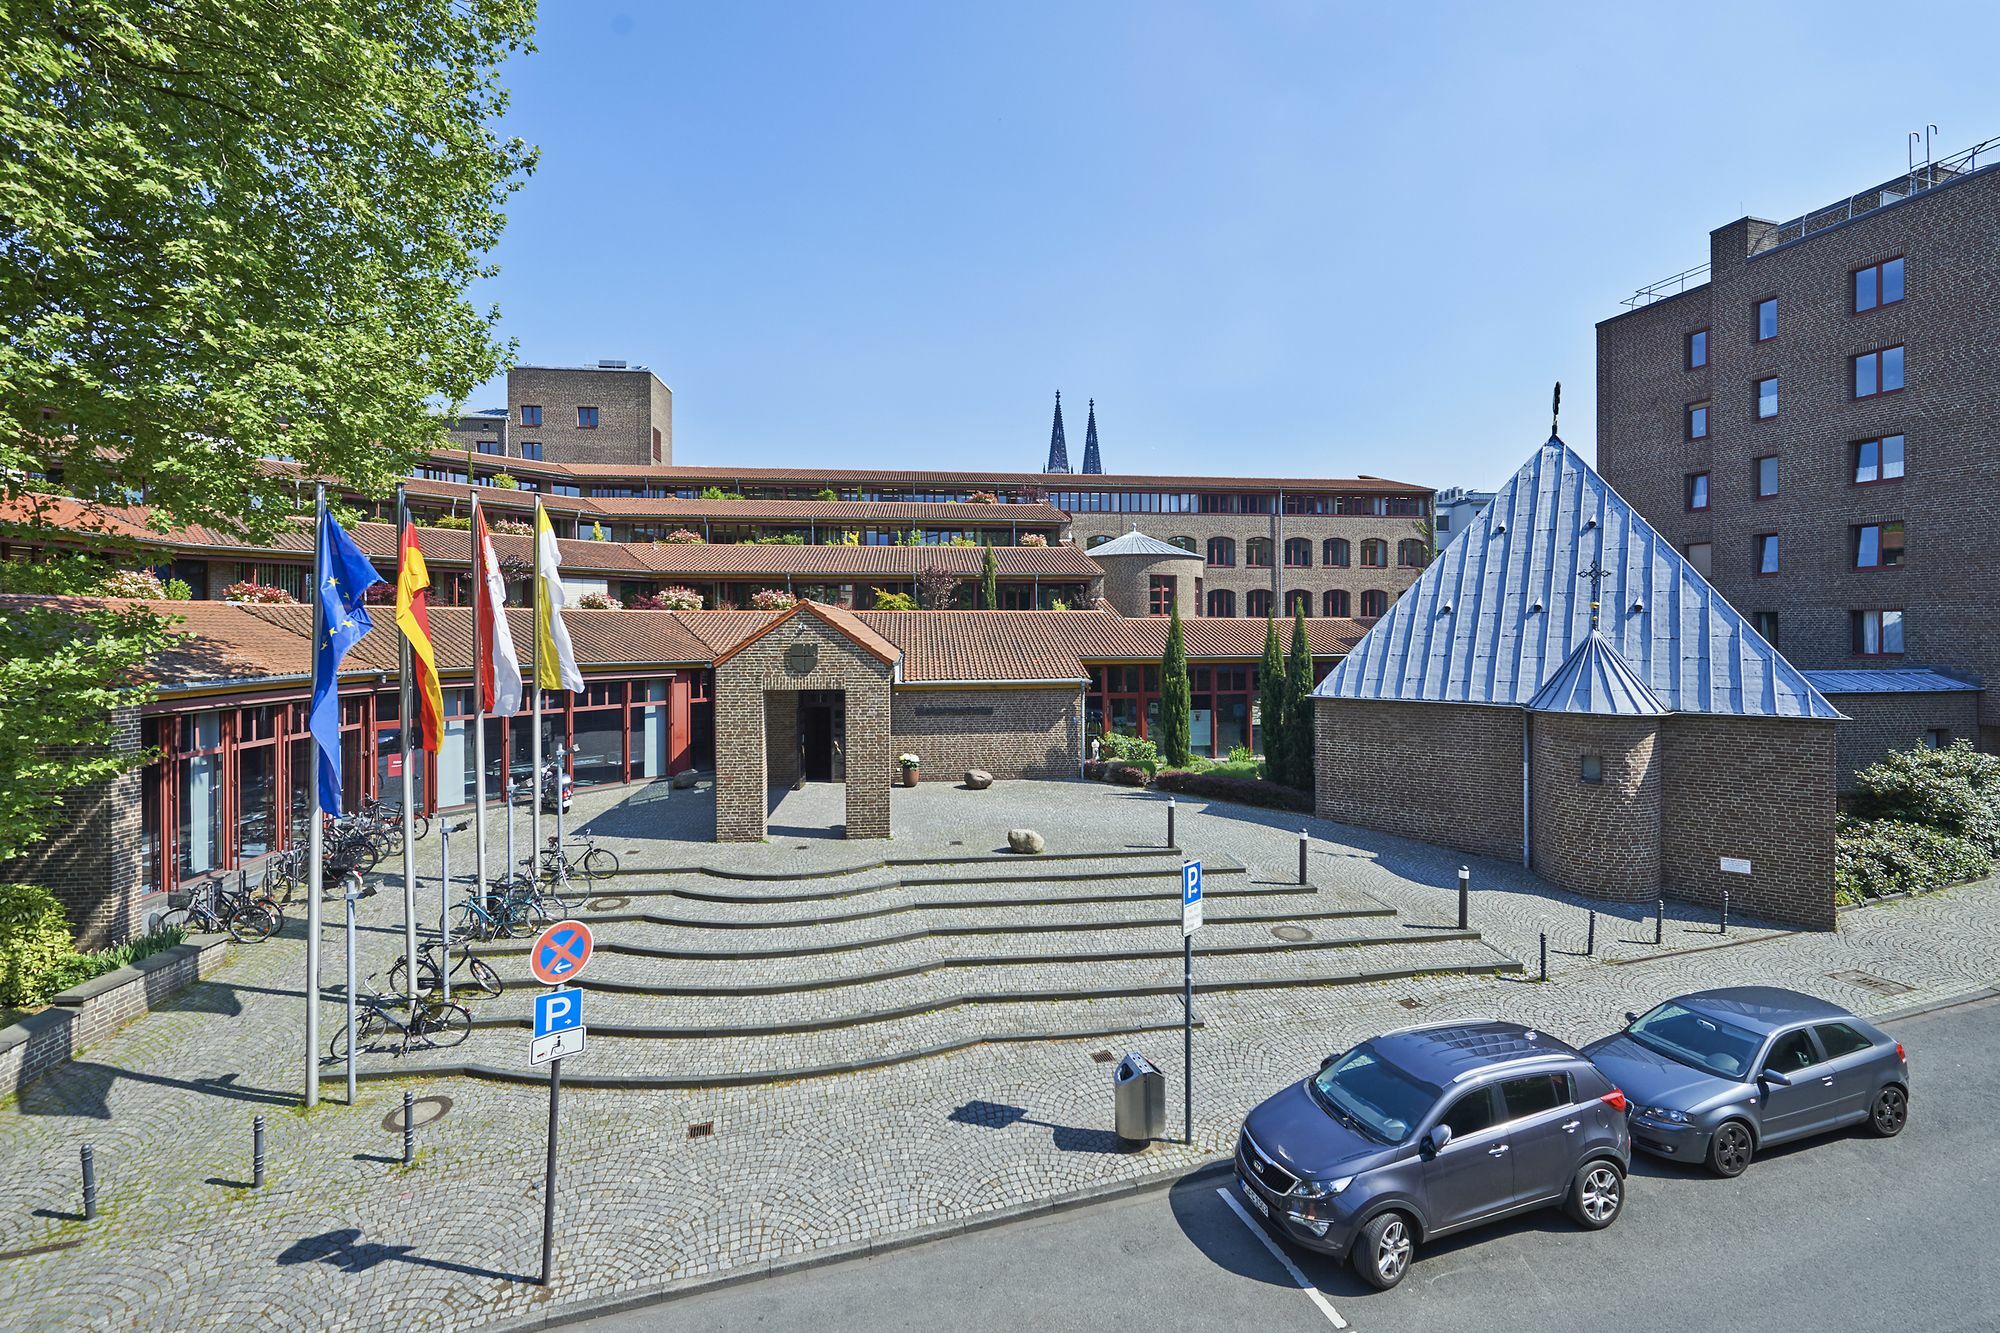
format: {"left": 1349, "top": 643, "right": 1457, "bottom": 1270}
{"left": 0, "top": 709, "right": 146, "bottom": 949}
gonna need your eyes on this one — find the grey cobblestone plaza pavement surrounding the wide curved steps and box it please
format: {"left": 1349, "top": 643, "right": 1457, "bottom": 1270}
{"left": 0, "top": 783, "right": 2000, "bottom": 1329}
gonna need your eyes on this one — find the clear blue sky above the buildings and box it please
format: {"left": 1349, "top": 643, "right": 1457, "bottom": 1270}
{"left": 472, "top": 0, "right": 2000, "bottom": 486}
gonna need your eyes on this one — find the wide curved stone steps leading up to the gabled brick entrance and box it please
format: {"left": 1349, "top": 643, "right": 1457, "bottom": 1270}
{"left": 364, "top": 849, "right": 1520, "bottom": 1089}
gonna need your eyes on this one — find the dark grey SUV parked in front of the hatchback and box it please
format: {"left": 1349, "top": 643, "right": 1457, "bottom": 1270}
{"left": 1236, "top": 1023, "right": 1632, "bottom": 1287}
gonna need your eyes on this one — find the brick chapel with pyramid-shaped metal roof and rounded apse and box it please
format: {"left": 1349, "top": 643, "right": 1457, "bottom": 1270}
{"left": 1314, "top": 438, "right": 1840, "bottom": 929}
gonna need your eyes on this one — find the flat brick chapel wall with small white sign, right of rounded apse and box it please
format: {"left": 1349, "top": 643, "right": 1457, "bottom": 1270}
{"left": 1660, "top": 715, "right": 1836, "bottom": 931}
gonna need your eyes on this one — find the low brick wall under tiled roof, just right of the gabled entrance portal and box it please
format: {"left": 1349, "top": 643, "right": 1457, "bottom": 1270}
{"left": 890, "top": 685, "right": 1082, "bottom": 783}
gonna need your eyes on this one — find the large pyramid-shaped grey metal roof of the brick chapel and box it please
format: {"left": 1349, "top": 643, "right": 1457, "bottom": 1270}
{"left": 1312, "top": 436, "right": 1840, "bottom": 721}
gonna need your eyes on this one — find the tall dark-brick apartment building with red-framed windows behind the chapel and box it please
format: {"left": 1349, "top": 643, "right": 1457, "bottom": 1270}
{"left": 1598, "top": 130, "right": 2000, "bottom": 781}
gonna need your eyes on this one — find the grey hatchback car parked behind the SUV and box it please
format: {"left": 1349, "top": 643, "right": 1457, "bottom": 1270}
{"left": 1584, "top": 987, "right": 1910, "bottom": 1175}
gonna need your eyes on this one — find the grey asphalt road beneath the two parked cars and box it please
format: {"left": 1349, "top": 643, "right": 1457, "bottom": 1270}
{"left": 576, "top": 1001, "right": 2000, "bottom": 1333}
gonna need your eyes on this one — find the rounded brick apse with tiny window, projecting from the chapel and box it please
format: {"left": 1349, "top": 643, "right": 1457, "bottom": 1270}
{"left": 1528, "top": 713, "right": 1662, "bottom": 903}
